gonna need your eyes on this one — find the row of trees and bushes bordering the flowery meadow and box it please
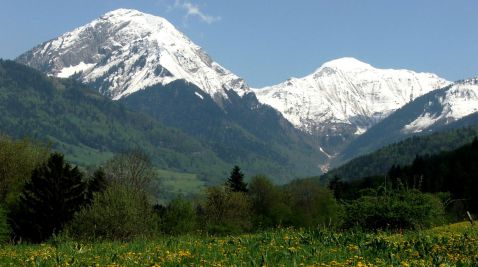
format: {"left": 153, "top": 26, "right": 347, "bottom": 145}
{"left": 0, "top": 136, "right": 462, "bottom": 243}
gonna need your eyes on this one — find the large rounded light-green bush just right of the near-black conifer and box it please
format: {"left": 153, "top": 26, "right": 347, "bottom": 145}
{"left": 67, "top": 185, "right": 158, "bottom": 240}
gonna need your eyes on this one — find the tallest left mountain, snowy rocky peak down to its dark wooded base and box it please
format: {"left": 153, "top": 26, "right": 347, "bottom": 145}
{"left": 17, "top": 9, "right": 326, "bottom": 182}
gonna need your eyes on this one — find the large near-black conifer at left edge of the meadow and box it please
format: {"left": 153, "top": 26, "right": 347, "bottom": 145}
{"left": 10, "top": 153, "right": 87, "bottom": 242}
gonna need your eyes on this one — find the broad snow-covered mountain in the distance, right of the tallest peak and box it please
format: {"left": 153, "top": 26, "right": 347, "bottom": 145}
{"left": 254, "top": 58, "right": 449, "bottom": 138}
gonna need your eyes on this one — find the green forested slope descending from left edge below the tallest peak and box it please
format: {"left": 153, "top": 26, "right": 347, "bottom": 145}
{"left": 0, "top": 60, "right": 230, "bottom": 182}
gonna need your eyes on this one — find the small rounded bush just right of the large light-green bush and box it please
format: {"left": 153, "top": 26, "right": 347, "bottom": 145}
{"left": 161, "top": 198, "right": 196, "bottom": 234}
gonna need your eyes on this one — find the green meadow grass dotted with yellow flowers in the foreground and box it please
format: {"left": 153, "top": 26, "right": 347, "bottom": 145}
{"left": 0, "top": 223, "right": 478, "bottom": 266}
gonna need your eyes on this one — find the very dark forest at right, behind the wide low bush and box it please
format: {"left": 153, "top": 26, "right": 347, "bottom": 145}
{"left": 328, "top": 138, "right": 478, "bottom": 220}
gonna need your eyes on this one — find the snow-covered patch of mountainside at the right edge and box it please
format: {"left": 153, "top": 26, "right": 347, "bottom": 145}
{"left": 402, "top": 77, "right": 478, "bottom": 133}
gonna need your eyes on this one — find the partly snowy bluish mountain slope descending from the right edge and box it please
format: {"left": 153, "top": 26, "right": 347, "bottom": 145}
{"left": 335, "top": 78, "right": 478, "bottom": 164}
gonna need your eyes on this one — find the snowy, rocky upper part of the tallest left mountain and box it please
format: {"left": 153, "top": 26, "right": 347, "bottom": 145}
{"left": 17, "top": 9, "right": 250, "bottom": 102}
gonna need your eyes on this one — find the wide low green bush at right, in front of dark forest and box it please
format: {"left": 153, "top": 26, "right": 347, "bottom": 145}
{"left": 344, "top": 190, "right": 445, "bottom": 230}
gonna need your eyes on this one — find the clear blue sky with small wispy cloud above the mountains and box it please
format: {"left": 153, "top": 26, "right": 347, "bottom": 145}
{"left": 0, "top": 0, "right": 478, "bottom": 87}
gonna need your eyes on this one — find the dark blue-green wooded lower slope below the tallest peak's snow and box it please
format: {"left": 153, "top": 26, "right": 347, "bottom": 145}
{"left": 120, "top": 80, "right": 326, "bottom": 183}
